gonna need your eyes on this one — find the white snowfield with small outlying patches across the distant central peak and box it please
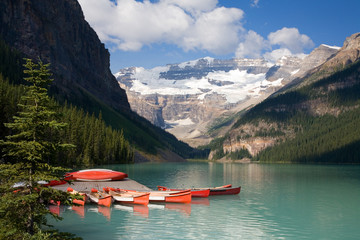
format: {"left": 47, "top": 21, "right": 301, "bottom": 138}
{"left": 115, "top": 57, "right": 299, "bottom": 104}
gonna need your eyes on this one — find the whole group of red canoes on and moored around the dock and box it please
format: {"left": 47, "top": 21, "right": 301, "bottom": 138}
{"left": 47, "top": 169, "right": 241, "bottom": 207}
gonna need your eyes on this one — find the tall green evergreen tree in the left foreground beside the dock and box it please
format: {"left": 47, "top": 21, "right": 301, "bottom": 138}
{"left": 0, "top": 59, "right": 79, "bottom": 239}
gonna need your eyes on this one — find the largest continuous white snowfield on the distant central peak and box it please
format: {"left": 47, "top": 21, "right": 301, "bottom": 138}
{"left": 130, "top": 67, "right": 278, "bottom": 103}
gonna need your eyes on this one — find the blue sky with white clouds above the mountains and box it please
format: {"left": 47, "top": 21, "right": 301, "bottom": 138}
{"left": 79, "top": 0, "right": 360, "bottom": 73}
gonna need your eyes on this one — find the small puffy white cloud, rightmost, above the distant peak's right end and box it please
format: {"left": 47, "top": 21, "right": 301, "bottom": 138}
{"left": 268, "top": 27, "right": 314, "bottom": 53}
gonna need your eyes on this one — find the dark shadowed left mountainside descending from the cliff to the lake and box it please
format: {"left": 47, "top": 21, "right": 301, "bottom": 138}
{"left": 0, "top": 0, "right": 200, "bottom": 160}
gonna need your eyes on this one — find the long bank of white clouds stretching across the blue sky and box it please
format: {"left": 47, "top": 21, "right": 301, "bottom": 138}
{"left": 79, "top": 0, "right": 314, "bottom": 61}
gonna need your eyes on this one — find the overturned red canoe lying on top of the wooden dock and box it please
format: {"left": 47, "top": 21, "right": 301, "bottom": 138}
{"left": 65, "top": 169, "right": 128, "bottom": 181}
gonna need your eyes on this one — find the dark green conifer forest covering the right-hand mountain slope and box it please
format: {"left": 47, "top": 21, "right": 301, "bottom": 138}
{"left": 209, "top": 61, "right": 360, "bottom": 163}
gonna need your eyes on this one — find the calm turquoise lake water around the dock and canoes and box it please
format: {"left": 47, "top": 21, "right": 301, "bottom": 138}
{"left": 51, "top": 162, "right": 360, "bottom": 240}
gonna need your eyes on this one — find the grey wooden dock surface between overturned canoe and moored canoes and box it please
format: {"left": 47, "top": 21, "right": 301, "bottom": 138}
{"left": 53, "top": 178, "right": 152, "bottom": 192}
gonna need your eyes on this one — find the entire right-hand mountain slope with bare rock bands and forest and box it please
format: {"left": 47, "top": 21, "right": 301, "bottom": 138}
{"left": 215, "top": 34, "right": 360, "bottom": 163}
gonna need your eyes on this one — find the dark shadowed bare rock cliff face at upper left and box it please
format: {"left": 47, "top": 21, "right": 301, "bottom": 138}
{"left": 0, "top": 0, "right": 130, "bottom": 111}
